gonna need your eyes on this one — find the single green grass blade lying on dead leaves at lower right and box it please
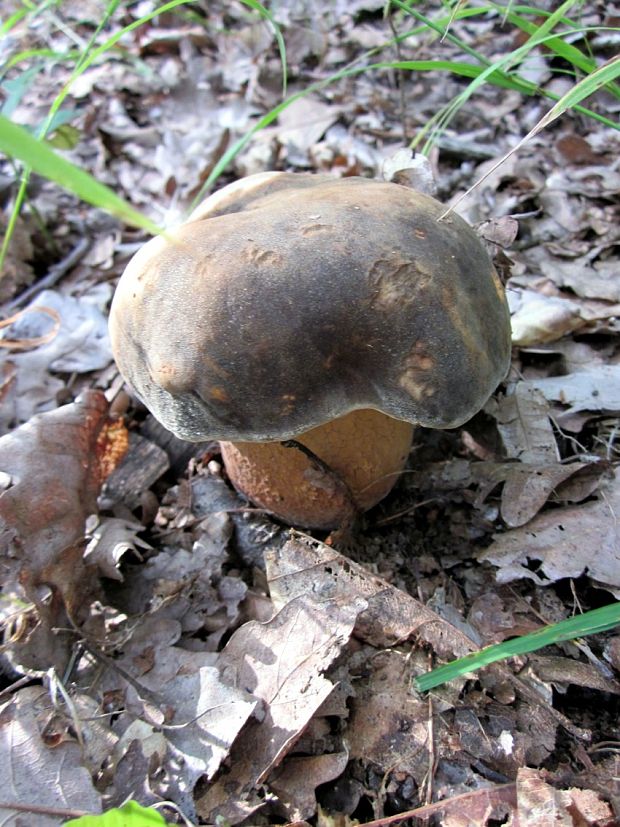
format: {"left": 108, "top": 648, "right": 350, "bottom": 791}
{"left": 414, "top": 603, "right": 620, "bottom": 692}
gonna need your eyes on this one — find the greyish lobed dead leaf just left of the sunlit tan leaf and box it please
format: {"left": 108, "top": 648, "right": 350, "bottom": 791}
{"left": 103, "top": 615, "right": 257, "bottom": 803}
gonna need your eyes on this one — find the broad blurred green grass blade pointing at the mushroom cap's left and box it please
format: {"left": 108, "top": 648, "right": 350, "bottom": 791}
{"left": 0, "top": 116, "right": 161, "bottom": 234}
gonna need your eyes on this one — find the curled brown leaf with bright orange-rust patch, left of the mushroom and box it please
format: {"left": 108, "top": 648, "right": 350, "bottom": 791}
{"left": 0, "top": 391, "right": 127, "bottom": 608}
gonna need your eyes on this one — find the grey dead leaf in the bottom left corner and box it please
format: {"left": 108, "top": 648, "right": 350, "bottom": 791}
{"left": 0, "top": 687, "right": 102, "bottom": 827}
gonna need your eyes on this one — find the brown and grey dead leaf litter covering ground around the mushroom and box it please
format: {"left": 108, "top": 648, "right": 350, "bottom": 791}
{"left": 0, "top": 0, "right": 620, "bottom": 827}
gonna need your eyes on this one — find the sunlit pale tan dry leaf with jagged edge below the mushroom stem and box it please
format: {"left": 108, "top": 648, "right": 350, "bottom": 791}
{"left": 196, "top": 593, "right": 364, "bottom": 824}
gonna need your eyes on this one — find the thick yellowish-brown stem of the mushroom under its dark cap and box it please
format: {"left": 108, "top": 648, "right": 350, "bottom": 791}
{"left": 220, "top": 409, "right": 413, "bottom": 529}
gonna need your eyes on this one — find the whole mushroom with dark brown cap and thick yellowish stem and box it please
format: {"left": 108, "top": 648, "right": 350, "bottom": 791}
{"left": 110, "top": 172, "right": 510, "bottom": 528}
